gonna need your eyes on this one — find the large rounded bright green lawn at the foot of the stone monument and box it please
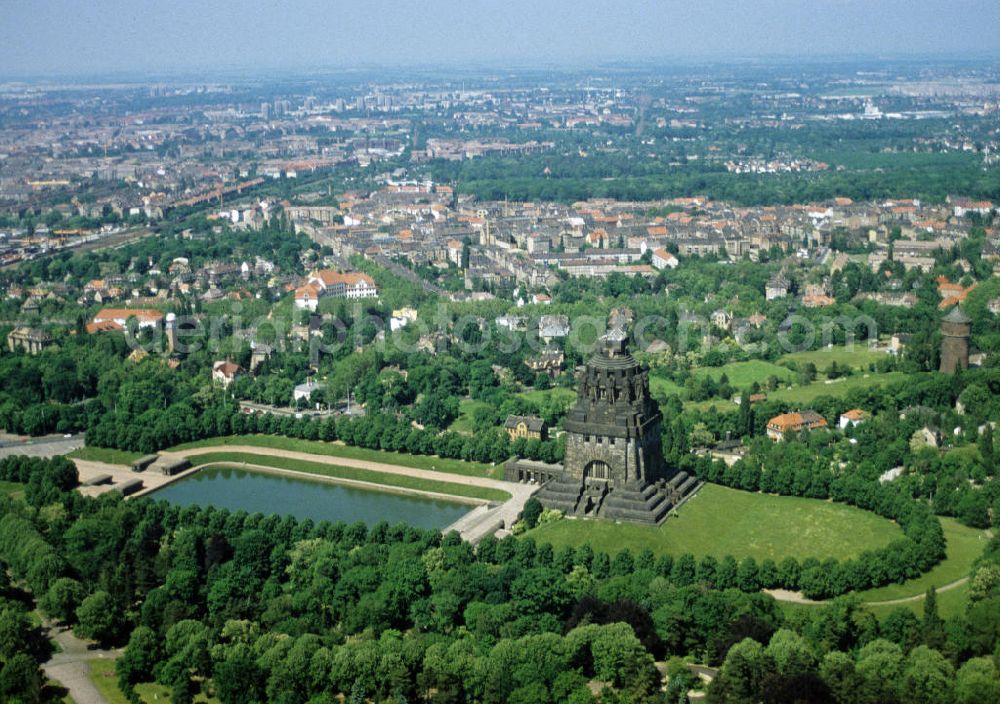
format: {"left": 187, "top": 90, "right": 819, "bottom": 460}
{"left": 526, "top": 484, "right": 902, "bottom": 561}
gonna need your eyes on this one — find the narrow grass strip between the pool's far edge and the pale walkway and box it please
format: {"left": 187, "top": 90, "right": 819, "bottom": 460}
{"left": 182, "top": 452, "right": 510, "bottom": 501}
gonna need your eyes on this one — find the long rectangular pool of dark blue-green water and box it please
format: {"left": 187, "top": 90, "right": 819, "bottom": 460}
{"left": 150, "top": 467, "right": 472, "bottom": 528}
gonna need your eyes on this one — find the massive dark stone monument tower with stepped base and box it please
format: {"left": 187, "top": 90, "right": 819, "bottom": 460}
{"left": 506, "top": 331, "right": 698, "bottom": 524}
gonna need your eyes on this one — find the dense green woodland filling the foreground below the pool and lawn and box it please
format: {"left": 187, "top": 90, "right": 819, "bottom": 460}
{"left": 0, "top": 458, "right": 1000, "bottom": 704}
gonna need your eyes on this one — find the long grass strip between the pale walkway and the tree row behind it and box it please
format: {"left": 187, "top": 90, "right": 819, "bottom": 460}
{"left": 170, "top": 435, "right": 503, "bottom": 477}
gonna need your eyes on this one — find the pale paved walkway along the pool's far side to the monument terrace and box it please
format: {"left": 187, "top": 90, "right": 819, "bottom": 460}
{"left": 160, "top": 445, "right": 540, "bottom": 543}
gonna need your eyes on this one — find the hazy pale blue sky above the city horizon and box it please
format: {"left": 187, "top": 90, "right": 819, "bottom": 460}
{"left": 0, "top": 0, "right": 1000, "bottom": 76}
